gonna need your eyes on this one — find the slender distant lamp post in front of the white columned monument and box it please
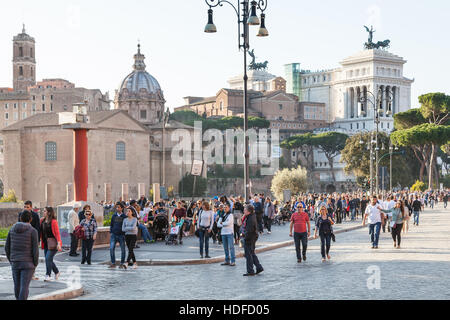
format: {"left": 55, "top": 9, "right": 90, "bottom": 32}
{"left": 358, "top": 88, "right": 394, "bottom": 195}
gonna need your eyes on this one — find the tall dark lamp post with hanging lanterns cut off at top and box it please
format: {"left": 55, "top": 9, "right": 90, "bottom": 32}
{"left": 205, "top": 0, "right": 269, "bottom": 202}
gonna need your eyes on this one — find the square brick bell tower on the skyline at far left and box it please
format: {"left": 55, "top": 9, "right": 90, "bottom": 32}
{"left": 13, "top": 25, "right": 36, "bottom": 91}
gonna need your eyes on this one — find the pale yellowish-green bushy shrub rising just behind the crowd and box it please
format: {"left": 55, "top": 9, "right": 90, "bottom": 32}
{"left": 270, "top": 166, "right": 309, "bottom": 199}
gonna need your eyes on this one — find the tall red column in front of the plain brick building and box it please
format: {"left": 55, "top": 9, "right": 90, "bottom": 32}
{"left": 73, "top": 129, "right": 88, "bottom": 201}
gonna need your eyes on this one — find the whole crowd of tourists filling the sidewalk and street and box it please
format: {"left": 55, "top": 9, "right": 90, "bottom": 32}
{"left": 5, "top": 190, "right": 450, "bottom": 299}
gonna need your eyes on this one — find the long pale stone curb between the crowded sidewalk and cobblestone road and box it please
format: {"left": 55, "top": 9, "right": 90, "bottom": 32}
{"left": 98, "top": 225, "right": 364, "bottom": 266}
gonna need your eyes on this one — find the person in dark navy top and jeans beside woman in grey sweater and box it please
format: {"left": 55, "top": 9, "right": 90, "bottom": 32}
{"left": 109, "top": 202, "right": 127, "bottom": 269}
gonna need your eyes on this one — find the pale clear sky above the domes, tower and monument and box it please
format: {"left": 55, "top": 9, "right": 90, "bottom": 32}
{"left": 0, "top": 0, "right": 450, "bottom": 110}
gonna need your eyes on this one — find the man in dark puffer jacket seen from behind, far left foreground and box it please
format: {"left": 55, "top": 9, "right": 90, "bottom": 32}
{"left": 5, "top": 211, "right": 39, "bottom": 300}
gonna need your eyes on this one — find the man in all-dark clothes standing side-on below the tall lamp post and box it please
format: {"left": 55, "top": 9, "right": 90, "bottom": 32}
{"left": 243, "top": 205, "right": 264, "bottom": 277}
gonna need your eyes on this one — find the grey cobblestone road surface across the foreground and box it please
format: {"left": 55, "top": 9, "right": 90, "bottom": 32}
{"left": 0, "top": 204, "right": 450, "bottom": 300}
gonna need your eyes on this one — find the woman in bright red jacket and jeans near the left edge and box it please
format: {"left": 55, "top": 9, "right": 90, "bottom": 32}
{"left": 40, "top": 207, "right": 62, "bottom": 281}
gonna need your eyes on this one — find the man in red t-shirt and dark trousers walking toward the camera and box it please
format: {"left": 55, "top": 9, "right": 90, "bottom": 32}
{"left": 289, "top": 204, "right": 311, "bottom": 263}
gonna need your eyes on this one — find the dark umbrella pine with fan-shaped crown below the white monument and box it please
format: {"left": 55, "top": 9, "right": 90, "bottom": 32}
{"left": 312, "top": 132, "right": 348, "bottom": 183}
